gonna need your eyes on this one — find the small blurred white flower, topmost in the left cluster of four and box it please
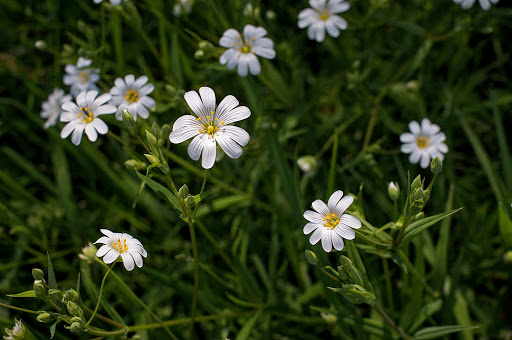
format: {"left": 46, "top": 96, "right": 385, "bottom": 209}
{"left": 64, "top": 57, "right": 100, "bottom": 97}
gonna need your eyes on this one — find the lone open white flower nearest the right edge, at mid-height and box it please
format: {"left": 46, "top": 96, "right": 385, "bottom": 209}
{"left": 400, "top": 118, "right": 448, "bottom": 169}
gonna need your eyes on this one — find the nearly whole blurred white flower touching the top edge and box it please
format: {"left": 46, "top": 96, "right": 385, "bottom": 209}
{"left": 298, "top": 0, "right": 350, "bottom": 42}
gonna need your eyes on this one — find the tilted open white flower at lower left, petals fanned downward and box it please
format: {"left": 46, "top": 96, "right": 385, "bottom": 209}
{"left": 94, "top": 229, "right": 148, "bottom": 271}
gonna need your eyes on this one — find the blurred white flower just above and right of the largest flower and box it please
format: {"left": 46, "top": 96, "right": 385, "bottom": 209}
{"left": 219, "top": 25, "right": 276, "bottom": 77}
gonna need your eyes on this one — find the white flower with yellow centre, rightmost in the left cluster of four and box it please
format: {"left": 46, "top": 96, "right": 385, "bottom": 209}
{"left": 109, "top": 74, "right": 155, "bottom": 120}
